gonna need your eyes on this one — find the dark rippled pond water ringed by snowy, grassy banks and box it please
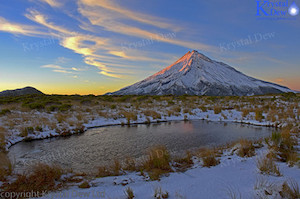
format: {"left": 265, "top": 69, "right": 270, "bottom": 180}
{"left": 8, "top": 120, "right": 272, "bottom": 172}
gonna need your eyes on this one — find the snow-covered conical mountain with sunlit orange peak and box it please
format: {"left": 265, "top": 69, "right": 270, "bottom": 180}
{"left": 109, "top": 50, "right": 293, "bottom": 96}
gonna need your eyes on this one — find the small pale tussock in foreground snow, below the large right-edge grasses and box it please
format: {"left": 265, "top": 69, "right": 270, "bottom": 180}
{"left": 257, "top": 156, "right": 281, "bottom": 176}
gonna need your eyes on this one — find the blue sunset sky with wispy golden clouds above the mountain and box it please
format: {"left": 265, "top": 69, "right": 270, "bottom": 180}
{"left": 0, "top": 0, "right": 300, "bottom": 95}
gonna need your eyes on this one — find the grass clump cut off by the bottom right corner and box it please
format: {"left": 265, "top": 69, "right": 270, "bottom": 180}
{"left": 279, "top": 180, "right": 300, "bottom": 199}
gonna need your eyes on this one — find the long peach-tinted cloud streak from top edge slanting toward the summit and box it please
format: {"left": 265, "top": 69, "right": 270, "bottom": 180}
{"left": 78, "top": 0, "right": 217, "bottom": 52}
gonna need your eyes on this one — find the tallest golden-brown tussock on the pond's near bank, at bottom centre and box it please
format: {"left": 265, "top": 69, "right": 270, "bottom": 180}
{"left": 142, "top": 146, "right": 172, "bottom": 180}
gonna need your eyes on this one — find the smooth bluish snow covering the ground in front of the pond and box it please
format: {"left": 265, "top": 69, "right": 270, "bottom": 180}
{"left": 38, "top": 148, "right": 300, "bottom": 199}
